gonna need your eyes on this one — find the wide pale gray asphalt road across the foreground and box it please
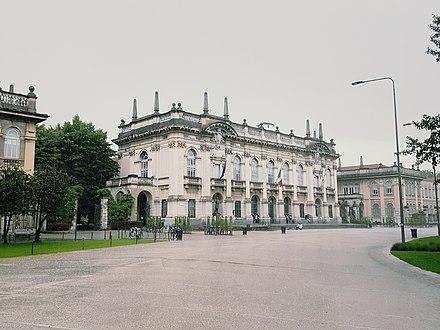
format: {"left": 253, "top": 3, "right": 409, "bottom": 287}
{"left": 0, "top": 228, "right": 440, "bottom": 329}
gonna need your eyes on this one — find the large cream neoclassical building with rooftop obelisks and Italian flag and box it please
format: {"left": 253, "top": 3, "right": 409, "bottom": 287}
{"left": 107, "top": 92, "right": 340, "bottom": 223}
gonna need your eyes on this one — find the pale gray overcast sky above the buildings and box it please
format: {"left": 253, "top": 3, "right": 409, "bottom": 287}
{"left": 0, "top": 0, "right": 440, "bottom": 169}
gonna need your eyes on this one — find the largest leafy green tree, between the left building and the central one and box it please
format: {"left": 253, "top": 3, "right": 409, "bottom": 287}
{"left": 35, "top": 116, "right": 119, "bottom": 224}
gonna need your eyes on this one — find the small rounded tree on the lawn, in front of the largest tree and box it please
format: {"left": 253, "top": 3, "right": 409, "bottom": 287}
{"left": 32, "top": 167, "right": 70, "bottom": 242}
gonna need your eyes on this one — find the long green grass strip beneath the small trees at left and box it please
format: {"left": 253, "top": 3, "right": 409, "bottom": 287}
{"left": 0, "top": 239, "right": 153, "bottom": 258}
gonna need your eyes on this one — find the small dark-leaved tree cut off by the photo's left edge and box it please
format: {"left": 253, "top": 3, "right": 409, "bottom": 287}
{"left": 0, "top": 166, "right": 30, "bottom": 243}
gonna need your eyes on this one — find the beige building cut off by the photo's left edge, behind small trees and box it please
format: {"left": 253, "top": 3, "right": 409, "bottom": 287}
{"left": 0, "top": 85, "right": 49, "bottom": 232}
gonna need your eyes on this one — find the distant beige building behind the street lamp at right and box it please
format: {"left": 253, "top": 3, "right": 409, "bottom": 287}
{"left": 337, "top": 157, "right": 437, "bottom": 223}
